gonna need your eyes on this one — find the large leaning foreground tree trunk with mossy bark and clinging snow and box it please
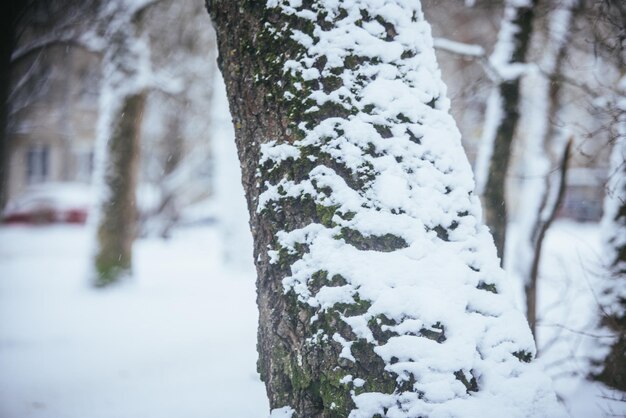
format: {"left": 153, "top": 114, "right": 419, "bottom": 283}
{"left": 207, "top": 0, "right": 560, "bottom": 417}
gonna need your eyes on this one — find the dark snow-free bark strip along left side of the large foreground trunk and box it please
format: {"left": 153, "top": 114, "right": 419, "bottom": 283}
{"left": 207, "top": 1, "right": 322, "bottom": 417}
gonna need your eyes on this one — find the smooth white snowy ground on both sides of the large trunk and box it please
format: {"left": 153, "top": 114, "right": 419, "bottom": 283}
{"left": 0, "top": 222, "right": 626, "bottom": 418}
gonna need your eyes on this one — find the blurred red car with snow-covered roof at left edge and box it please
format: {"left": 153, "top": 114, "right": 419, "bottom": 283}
{"left": 2, "top": 183, "right": 93, "bottom": 224}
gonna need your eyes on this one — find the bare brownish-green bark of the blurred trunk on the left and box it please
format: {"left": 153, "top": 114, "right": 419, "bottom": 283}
{"left": 95, "top": 93, "right": 145, "bottom": 286}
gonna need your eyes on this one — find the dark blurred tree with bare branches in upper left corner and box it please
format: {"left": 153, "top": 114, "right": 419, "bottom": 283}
{"left": 0, "top": 0, "right": 96, "bottom": 209}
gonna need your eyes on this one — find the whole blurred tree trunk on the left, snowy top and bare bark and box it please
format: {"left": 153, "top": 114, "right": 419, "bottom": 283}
{"left": 94, "top": 0, "right": 149, "bottom": 286}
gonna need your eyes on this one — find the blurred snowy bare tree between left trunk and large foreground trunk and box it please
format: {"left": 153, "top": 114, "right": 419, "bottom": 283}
{"left": 139, "top": 0, "right": 217, "bottom": 237}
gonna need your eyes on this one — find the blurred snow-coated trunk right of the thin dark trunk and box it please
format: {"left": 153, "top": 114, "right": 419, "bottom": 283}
{"left": 505, "top": 0, "right": 577, "bottom": 335}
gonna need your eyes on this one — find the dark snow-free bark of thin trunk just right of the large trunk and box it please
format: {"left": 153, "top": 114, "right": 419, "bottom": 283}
{"left": 482, "top": 1, "right": 536, "bottom": 259}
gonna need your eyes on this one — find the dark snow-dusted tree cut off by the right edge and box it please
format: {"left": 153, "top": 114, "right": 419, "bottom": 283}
{"left": 579, "top": 2, "right": 626, "bottom": 391}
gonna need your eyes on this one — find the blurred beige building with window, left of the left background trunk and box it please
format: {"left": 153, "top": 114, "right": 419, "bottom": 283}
{"left": 8, "top": 44, "right": 100, "bottom": 197}
